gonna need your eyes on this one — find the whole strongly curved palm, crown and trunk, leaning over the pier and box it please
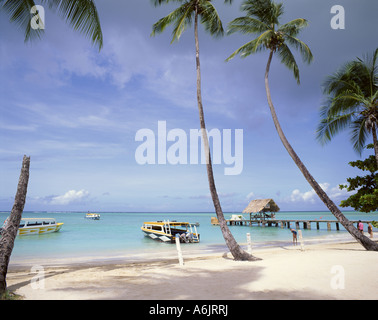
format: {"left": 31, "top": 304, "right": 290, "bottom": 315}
{"left": 227, "top": 0, "right": 378, "bottom": 251}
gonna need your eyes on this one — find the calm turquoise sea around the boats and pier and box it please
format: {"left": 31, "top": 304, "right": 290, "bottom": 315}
{"left": 0, "top": 211, "right": 378, "bottom": 264}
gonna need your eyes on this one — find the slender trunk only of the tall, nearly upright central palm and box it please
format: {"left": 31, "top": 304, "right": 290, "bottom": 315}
{"left": 194, "top": 12, "right": 260, "bottom": 261}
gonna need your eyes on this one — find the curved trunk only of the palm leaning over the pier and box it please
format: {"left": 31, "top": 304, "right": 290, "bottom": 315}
{"left": 265, "top": 50, "right": 378, "bottom": 251}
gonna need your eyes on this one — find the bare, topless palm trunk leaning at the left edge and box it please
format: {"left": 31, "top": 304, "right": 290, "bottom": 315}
{"left": 0, "top": 156, "right": 30, "bottom": 294}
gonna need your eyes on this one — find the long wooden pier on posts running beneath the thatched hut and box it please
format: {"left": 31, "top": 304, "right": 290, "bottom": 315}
{"left": 211, "top": 217, "right": 371, "bottom": 230}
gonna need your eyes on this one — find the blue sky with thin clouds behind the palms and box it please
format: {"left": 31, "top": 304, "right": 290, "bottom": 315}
{"left": 0, "top": 0, "right": 378, "bottom": 212}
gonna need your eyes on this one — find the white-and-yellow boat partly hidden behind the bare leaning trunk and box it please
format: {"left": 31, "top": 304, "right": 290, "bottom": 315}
{"left": 3, "top": 218, "right": 63, "bottom": 236}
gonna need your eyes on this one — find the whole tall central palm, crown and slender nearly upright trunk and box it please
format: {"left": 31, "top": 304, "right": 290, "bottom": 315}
{"left": 152, "top": 0, "right": 258, "bottom": 260}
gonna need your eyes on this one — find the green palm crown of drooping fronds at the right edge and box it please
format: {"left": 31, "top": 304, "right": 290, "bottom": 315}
{"left": 317, "top": 48, "right": 378, "bottom": 165}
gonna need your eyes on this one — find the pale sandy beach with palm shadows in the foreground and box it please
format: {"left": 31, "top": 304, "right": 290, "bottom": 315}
{"left": 7, "top": 242, "right": 378, "bottom": 300}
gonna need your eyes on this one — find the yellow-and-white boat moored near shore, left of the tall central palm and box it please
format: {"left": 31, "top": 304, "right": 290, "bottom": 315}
{"left": 141, "top": 220, "right": 200, "bottom": 243}
